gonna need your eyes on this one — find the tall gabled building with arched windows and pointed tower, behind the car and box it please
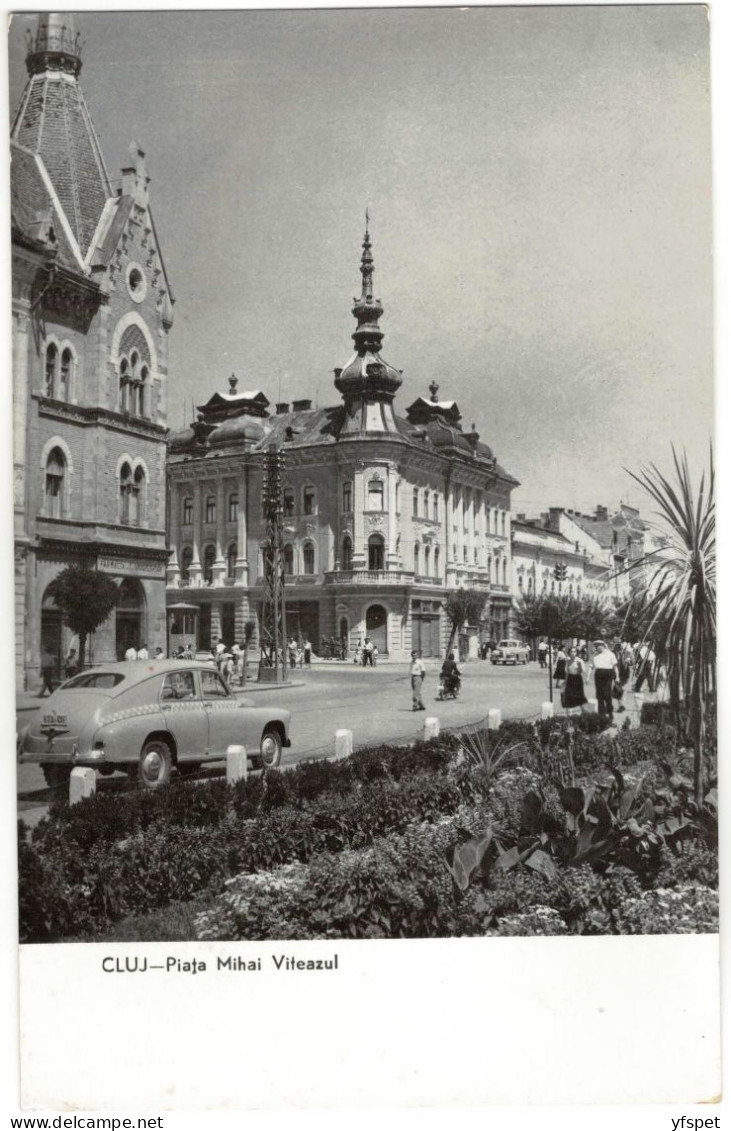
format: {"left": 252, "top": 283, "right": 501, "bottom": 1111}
{"left": 10, "top": 12, "right": 173, "bottom": 689}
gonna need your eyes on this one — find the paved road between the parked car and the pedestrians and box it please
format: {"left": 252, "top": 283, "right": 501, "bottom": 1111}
{"left": 18, "top": 661, "right": 588, "bottom": 823}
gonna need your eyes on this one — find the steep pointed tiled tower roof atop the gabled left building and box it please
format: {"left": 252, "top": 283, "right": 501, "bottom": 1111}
{"left": 10, "top": 12, "right": 113, "bottom": 268}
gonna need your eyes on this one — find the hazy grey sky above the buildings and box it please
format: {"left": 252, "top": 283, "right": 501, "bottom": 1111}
{"left": 9, "top": 5, "right": 713, "bottom": 513}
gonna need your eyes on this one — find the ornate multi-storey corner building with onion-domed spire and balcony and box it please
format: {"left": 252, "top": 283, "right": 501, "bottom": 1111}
{"left": 167, "top": 223, "right": 517, "bottom": 659}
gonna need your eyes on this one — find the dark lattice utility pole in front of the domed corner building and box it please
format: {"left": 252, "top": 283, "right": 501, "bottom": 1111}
{"left": 259, "top": 444, "right": 287, "bottom": 683}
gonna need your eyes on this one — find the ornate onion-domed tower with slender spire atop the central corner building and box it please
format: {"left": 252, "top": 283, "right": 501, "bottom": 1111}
{"left": 335, "top": 213, "right": 402, "bottom": 437}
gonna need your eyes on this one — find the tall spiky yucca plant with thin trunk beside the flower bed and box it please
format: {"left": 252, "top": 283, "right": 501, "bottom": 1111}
{"left": 629, "top": 448, "right": 716, "bottom": 805}
